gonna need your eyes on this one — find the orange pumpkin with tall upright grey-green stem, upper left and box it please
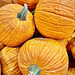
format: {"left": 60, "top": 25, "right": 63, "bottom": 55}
{"left": 0, "top": 4, "right": 35, "bottom": 46}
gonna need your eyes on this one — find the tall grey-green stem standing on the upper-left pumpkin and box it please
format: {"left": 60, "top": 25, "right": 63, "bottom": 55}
{"left": 17, "top": 4, "right": 28, "bottom": 21}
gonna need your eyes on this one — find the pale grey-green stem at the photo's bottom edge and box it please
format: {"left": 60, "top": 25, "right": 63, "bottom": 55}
{"left": 28, "top": 64, "right": 41, "bottom": 75}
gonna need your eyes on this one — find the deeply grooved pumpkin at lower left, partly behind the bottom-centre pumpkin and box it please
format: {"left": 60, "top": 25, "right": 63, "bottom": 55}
{"left": 1, "top": 47, "right": 21, "bottom": 75}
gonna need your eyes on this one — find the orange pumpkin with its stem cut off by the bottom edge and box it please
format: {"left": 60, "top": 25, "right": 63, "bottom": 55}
{"left": 18, "top": 38, "right": 68, "bottom": 75}
